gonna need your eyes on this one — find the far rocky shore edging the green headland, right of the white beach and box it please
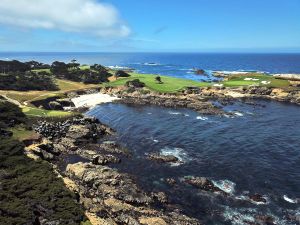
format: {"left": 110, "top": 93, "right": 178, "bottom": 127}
{"left": 101, "top": 83, "right": 300, "bottom": 107}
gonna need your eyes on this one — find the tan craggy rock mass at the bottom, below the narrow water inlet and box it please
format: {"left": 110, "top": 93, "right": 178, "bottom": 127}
{"left": 66, "top": 163, "right": 199, "bottom": 225}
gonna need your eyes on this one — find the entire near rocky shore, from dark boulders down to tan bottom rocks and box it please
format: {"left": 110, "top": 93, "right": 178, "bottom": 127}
{"left": 26, "top": 117, "right": 200, "bottom": 225}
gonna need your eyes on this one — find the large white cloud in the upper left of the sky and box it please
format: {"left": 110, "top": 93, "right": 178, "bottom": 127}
{"left": 0, "top": 0, "right": 130, "bottom": 37}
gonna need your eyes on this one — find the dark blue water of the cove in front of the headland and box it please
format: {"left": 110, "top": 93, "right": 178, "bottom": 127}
{"left": 87, "top": 101, "right": 300, "bottom": 224}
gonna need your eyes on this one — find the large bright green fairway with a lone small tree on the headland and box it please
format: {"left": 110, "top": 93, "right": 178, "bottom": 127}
{"left": 106, "top": 73, "right": 211, "bottom": 93}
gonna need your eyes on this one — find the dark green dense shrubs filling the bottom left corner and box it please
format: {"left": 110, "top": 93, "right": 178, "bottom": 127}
{"left": 0, "top": 100, "right": 86, "bottom": 224}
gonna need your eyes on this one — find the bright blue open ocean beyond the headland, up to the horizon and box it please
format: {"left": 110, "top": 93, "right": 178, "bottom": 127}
{"left": 0, "top": 52, "right": 300, "bottom": 80}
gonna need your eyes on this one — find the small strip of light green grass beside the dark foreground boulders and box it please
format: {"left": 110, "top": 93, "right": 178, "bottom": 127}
{"left": 22, "top": 107, "right": 74, "bottom": 117}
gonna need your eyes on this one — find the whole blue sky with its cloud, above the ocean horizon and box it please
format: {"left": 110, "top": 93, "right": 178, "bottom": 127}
{"left": 0, "top": 0, "right": 300, "bottom": 53}
